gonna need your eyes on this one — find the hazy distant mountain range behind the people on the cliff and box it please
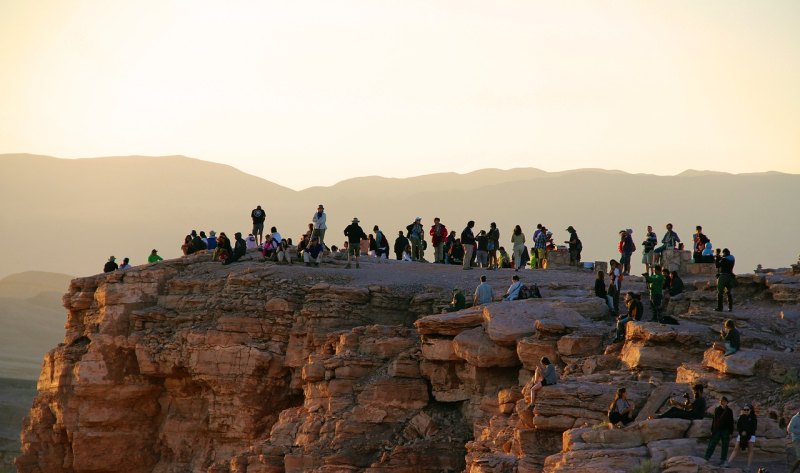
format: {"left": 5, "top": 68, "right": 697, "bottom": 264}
{"left": 0, "top": 154, "right": 800, "bottom": 277}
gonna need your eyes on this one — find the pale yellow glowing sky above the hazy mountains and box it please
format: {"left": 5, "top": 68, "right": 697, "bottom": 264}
{"left": 0, "top": 0, "right": 800, "bottom": 189}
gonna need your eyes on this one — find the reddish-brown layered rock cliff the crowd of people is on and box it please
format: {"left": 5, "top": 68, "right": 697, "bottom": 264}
{"left": 12, "top": 249, "right": 800, "bottom": 473}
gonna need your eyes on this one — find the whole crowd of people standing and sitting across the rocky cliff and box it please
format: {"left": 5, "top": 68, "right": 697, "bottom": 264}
{"left": 94, "top": 204, "right": 800, "bottom": 472}
